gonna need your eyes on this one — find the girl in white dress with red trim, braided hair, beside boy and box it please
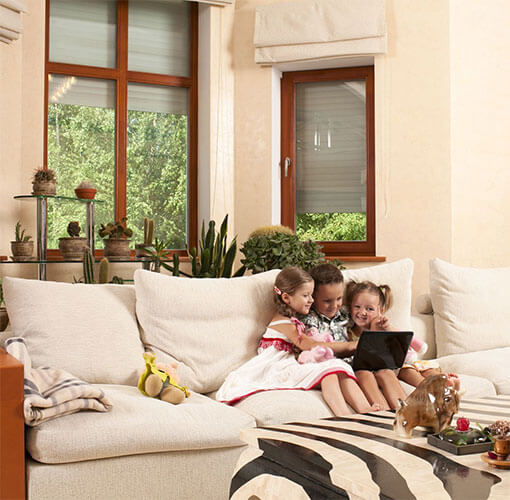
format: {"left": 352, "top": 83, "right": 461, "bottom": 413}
{"left": 216, "top": 266, "right": 379, "bottom": 416}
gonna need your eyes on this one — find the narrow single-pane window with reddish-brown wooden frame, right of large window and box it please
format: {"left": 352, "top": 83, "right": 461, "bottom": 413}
{"left": 281, "top": 66, "right": 375, "bottom": 256}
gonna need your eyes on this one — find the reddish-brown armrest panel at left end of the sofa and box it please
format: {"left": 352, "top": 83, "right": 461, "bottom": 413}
{"left": 0, "top": 349, "right": 25, "bottom": 499}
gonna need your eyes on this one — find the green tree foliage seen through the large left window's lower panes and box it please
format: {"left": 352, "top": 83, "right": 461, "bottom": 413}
{"left": 48, "top": 104, "right": 188, "bottom": 249}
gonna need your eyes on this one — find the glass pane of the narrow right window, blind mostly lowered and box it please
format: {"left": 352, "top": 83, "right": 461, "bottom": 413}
{"left": 296, "top": 80, "right": 366, "bottom": 241}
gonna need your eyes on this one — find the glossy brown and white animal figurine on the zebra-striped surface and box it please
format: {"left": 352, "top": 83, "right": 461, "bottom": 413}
{"left": 393, "top": 373, "right": 461, "bottom": 438}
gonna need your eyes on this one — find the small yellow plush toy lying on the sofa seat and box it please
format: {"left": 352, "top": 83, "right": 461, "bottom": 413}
{"left": 138, "top": 352, "right": 189, "bottom": 404}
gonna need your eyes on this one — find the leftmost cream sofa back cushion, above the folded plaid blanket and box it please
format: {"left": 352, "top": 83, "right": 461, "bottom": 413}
{"left": 4, "top": 278, "right": 144, "bottom": 385}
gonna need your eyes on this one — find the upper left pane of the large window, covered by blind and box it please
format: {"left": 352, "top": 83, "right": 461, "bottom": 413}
{"left": 49, "top": 0, "right": 117, "bottom": 68}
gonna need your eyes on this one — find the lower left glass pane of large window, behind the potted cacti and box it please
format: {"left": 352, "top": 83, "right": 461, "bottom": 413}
{"left": 48, "top": 75, "right": 115, "bottom": 248}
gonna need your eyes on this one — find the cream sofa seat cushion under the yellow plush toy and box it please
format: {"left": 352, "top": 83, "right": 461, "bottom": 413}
{"left": 27, "top": 385, "right": 255, "bottom": 462}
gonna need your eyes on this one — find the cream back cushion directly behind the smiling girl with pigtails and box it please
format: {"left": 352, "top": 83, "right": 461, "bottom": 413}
{"left": 342, "top": 259, "right": 414, "bottom": 330}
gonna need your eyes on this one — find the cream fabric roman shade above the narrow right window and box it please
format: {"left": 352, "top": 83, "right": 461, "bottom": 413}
{"left": 253, "top": 0, "right": 386, "bottom": 64}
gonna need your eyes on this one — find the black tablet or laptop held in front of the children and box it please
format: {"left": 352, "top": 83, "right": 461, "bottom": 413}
{"left": 352, "top": 330, "right": 413, "bottom": 371}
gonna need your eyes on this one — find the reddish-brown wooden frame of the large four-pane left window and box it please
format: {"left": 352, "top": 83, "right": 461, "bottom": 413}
{"left": 43, "top": 0, "right": 198, "bottom": 258}
